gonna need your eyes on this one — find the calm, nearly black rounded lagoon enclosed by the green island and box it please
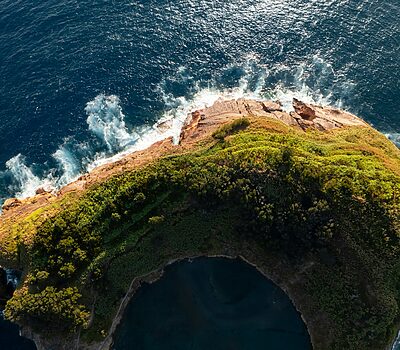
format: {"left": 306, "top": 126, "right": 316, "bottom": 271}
{"left": 113, "top": 258, "right": 311, "bottom": 350}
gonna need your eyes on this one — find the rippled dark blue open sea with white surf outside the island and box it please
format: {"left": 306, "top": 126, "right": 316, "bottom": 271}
{"left": 0, "top": 0, "right": 400, "bottom": 348}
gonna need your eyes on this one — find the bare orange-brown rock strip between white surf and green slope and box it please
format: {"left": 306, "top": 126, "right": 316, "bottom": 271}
{"left": 0, "top": 99, "right": 388, "bottom": 350}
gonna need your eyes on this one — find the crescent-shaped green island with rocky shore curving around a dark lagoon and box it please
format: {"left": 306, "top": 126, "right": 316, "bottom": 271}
{"left": 0, "top": 101, "right": 400, "bottom": 350}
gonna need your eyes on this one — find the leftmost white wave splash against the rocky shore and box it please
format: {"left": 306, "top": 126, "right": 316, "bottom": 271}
{"left": 6, "top": 154, "right": 53, "bottom": 198}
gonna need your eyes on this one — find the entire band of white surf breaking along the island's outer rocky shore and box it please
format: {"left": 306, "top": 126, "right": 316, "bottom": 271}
{"left": 0, "top": 56, "right": 400, "bottom": 200}
